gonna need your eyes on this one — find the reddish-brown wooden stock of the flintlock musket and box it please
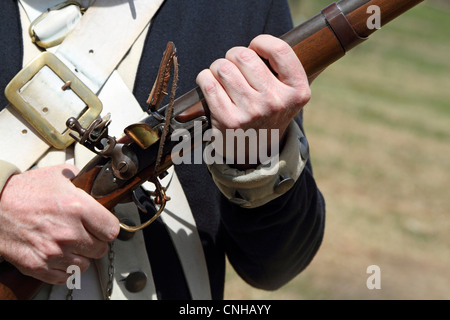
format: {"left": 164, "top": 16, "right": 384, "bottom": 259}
{"left": 0, "top": 0, "right": 423, "bottom": 300}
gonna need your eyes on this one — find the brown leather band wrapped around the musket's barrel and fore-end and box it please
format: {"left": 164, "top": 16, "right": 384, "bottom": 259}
{"left": 322, "top": 3, "right": 367, "bottom": 53}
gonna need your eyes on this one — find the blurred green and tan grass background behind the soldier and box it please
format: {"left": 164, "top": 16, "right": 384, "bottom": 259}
{"left": 225, "top": 0, "right": 450, "bottom": 299}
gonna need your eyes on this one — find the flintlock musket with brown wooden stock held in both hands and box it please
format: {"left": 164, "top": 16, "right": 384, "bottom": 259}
{"left": 0, "top": 0, "right": 423, "bottom": 300}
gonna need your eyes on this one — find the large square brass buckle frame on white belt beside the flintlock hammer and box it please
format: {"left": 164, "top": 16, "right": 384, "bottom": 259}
{"left": 5, "top": 52, "right": 103, "bottom": 149}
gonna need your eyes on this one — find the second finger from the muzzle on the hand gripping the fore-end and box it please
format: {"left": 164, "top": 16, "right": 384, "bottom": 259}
{"left": 225, "top": 47, "right": 278, "bottom": 92}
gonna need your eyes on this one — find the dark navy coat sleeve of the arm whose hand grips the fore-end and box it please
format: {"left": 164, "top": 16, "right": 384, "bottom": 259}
{"left": 215, "top": 1, "right": 325, "bottom": 290}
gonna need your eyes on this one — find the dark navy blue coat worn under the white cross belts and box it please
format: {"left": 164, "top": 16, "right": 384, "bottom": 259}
{"left": 0, "top": 0, "right": 325, "bottom": 299}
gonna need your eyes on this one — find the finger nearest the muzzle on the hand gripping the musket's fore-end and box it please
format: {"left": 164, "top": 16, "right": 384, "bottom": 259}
{"left": 249, "top": 35, "right": 308, "bottom": 87}
